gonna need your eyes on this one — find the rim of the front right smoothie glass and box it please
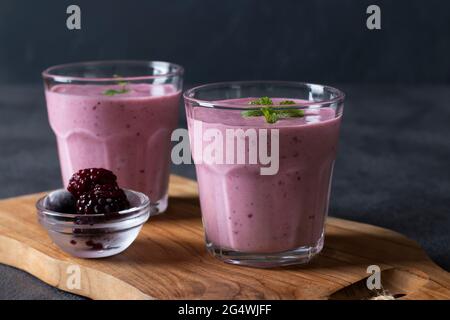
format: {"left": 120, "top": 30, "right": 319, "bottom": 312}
{"left": 183, "top": 80, "right": 345, "bottom": 110}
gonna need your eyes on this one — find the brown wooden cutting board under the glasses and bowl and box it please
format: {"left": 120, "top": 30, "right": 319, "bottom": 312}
{"left": 0, "top": 176, "right": 450, "bottom": 299}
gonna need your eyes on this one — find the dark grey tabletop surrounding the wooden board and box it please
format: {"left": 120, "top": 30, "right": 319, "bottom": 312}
{"left": 0, "top": 85, "right": 450, "bottom": 299}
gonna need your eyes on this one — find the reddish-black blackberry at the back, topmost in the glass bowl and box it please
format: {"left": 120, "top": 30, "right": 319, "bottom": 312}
{"left": 67, "top": 168, "right": 117, "bottom": 199}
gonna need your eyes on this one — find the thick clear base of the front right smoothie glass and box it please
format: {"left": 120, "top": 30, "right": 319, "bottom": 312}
{"left": 206, "top": 234, "right": 324, "bottom": 268}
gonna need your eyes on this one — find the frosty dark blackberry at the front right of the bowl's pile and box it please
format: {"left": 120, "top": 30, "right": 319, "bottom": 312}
{"left": 76, "top": 185, "right": 130, "bottom": 215}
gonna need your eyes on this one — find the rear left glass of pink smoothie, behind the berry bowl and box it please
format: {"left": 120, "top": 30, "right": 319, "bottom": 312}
{"left": 43, "top": 61, "right": 183, "bottom": 213}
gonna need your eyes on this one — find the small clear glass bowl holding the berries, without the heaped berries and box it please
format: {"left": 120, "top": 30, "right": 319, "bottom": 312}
{"left": 36, "top": 189, "right": 151, "bottom": 258}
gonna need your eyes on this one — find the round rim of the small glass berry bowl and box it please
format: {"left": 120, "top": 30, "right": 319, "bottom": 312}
{"left": 36, "top": 189, "right": 150, "bottom": 220}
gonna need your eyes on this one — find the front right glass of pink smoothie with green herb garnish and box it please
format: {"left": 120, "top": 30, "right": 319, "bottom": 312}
{"left": 184, "top": 81, "right": 344, "bottom": 267}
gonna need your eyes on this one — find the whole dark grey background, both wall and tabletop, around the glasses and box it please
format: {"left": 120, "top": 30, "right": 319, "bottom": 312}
{"left": 0, "top": 0, "right": 450, "bottom": 299}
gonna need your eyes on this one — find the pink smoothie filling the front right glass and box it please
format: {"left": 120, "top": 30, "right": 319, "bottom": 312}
{"left": 188, "top": 99, "right": 341, "bottom": 253}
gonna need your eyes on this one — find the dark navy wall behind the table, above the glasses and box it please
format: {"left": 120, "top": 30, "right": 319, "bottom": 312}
{"left": 0, "top": 0, "right": 450, "bottom": 84}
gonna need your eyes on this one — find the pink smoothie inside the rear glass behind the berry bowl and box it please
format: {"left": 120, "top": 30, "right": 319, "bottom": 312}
{"left": 46, "top": 84, "right": 180, "bottom": 206}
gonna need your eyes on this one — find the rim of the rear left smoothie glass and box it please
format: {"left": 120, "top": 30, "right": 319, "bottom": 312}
{"left": 41, "top": 60, "right": 184, "bottom": 82}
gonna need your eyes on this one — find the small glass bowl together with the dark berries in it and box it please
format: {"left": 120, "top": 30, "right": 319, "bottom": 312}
{"left": 36, "top": 168, "right": 151, "bottom": 258}
